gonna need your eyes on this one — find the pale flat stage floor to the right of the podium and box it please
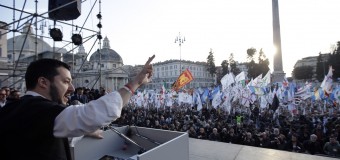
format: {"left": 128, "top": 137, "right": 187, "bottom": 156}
{"left": 189, "top": 138, "right": 338, "bottom": 160}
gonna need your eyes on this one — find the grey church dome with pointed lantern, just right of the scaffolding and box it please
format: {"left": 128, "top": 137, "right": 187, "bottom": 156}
{"left": 90, "top": 37, "right": 123, "bottom": 63}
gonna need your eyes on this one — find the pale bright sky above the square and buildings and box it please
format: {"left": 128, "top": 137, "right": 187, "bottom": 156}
{"left": 0, "top": 0, "right": 340, "bottom": 77}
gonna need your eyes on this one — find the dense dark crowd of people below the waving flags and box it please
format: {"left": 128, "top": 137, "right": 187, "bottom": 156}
{"left": 113, "top": 101, "right": 340, "bottom": 157}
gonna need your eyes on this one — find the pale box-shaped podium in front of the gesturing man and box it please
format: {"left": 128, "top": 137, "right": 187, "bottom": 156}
{"left": 71, "top": 126, "right": 189, "bottom": 160}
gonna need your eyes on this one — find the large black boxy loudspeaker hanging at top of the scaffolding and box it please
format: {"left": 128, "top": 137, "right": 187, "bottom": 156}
{"left": 48, "top": 0, "right": 81, "bottom": 21}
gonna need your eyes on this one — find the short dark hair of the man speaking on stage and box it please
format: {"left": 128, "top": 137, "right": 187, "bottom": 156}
{"left": 25, "top": 59, "right": 70, "bottom": 89}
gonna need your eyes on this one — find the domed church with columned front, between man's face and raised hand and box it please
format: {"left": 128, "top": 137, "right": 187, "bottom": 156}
{"left": 73, "top": 37, "right": 128, "bottom": 91}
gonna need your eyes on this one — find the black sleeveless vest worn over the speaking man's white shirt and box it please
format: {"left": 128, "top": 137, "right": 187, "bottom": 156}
{"left": 0, "top": 96, "right": 71, "bottom": 160}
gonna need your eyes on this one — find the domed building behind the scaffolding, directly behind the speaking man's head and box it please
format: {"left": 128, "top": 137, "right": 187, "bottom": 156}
{"left": 0, "top": 23, "right": 66, "bottom": 91}
